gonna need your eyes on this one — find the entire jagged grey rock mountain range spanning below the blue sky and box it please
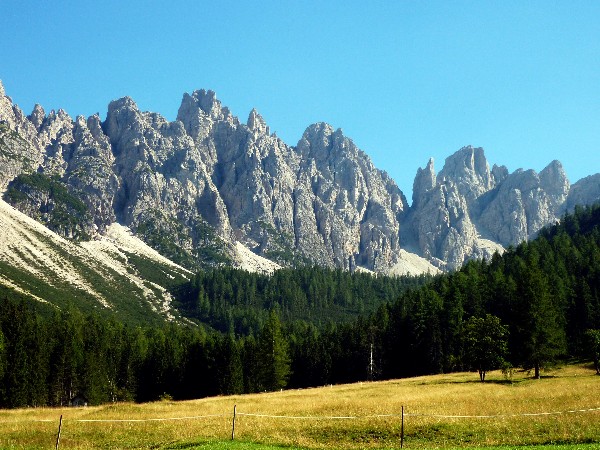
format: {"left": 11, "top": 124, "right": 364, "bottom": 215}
{"left": 0, "top": 79, "right": 600, "bottom": 273}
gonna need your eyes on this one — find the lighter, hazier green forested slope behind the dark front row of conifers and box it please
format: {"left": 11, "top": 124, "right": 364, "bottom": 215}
{"left": 176, "top": 266, "right": 433, "bottom": 335}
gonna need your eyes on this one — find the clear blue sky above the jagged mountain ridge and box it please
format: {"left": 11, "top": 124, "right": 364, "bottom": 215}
{"left": 0, "top": 0, "right": 600, "bottom": 199}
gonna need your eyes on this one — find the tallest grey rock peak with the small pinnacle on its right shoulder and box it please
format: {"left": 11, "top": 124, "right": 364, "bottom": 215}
{"left": 177, "top": 90, "right": 297, "bottom": 264}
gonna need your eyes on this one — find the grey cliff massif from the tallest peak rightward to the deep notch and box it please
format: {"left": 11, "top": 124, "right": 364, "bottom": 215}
{"left": 173, "top": 91, "right": 406, "bottom": 270}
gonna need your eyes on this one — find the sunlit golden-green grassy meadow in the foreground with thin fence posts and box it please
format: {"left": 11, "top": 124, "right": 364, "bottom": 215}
{"left": 0, "top": 366, "right": 600, "bottom": 450}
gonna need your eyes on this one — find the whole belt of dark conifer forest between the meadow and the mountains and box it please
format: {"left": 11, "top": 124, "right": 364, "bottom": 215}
{"left": 0, "top": 206, "right": 600, "bottom": 407}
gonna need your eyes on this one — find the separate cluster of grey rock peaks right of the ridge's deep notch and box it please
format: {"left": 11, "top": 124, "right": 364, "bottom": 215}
{"left": 405, "top": 147, "right": 572, "bottom": 268}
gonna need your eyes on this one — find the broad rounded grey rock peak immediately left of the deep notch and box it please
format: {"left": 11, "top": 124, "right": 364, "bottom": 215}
{"left": 296, "top": 123, "right": 406, "bottom": 271}
